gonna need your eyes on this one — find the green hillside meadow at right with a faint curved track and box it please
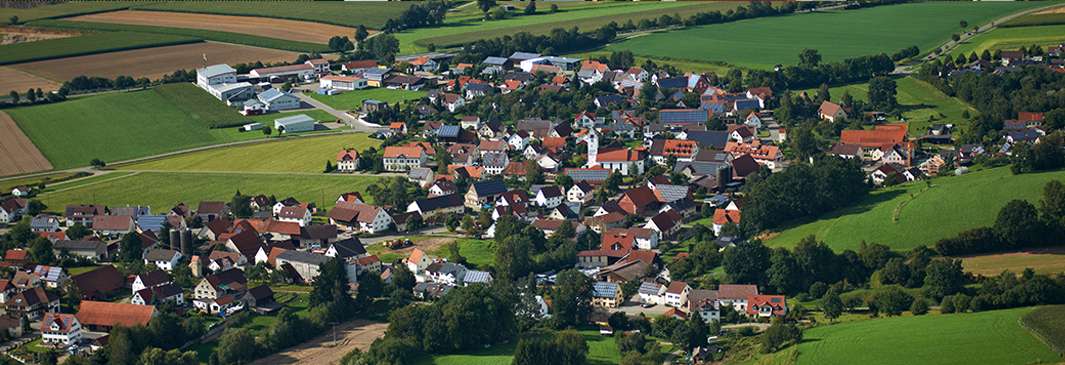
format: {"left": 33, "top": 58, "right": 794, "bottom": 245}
{"left": 767, "top": 167, "right": 1065, "bottom": 252}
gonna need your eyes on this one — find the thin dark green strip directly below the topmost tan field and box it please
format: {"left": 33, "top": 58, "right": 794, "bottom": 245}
{"left": 29, "top": 20, "right": 329, "bottom": 53}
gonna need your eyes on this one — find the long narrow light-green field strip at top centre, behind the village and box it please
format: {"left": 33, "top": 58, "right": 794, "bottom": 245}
{"left": 406, "top": 1, "right": 739, "bottom": 52}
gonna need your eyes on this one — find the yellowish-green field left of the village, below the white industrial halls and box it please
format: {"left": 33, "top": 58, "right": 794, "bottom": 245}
{"left": 120, "top": 131, "right": 380, "bottom": 174}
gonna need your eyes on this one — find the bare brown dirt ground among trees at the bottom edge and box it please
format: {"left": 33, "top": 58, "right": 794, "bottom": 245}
{"left": 251, "top": 319, "right": 389, "bottom": 365}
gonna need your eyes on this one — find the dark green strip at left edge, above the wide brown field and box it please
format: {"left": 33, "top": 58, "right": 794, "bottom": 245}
{"left": 0, "top": 32, "right": 202, "bottom": 65}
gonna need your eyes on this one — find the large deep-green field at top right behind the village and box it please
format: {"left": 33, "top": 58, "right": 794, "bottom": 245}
{"left": 606, "top": 2, "right": 1041, "bottom": 69}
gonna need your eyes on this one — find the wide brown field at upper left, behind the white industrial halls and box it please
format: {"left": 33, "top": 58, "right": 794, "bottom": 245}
{"left": 12, "top": 42, "right": 299, "bottom": 81}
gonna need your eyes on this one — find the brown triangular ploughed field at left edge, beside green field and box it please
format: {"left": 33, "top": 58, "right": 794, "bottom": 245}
{"left": 0, "top": 112, "right": 52, "bottom": 177}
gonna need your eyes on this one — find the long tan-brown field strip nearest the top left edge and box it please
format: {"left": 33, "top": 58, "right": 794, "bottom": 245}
{"left": 71, "top": 11, "right": 356, "bottom": 44}
